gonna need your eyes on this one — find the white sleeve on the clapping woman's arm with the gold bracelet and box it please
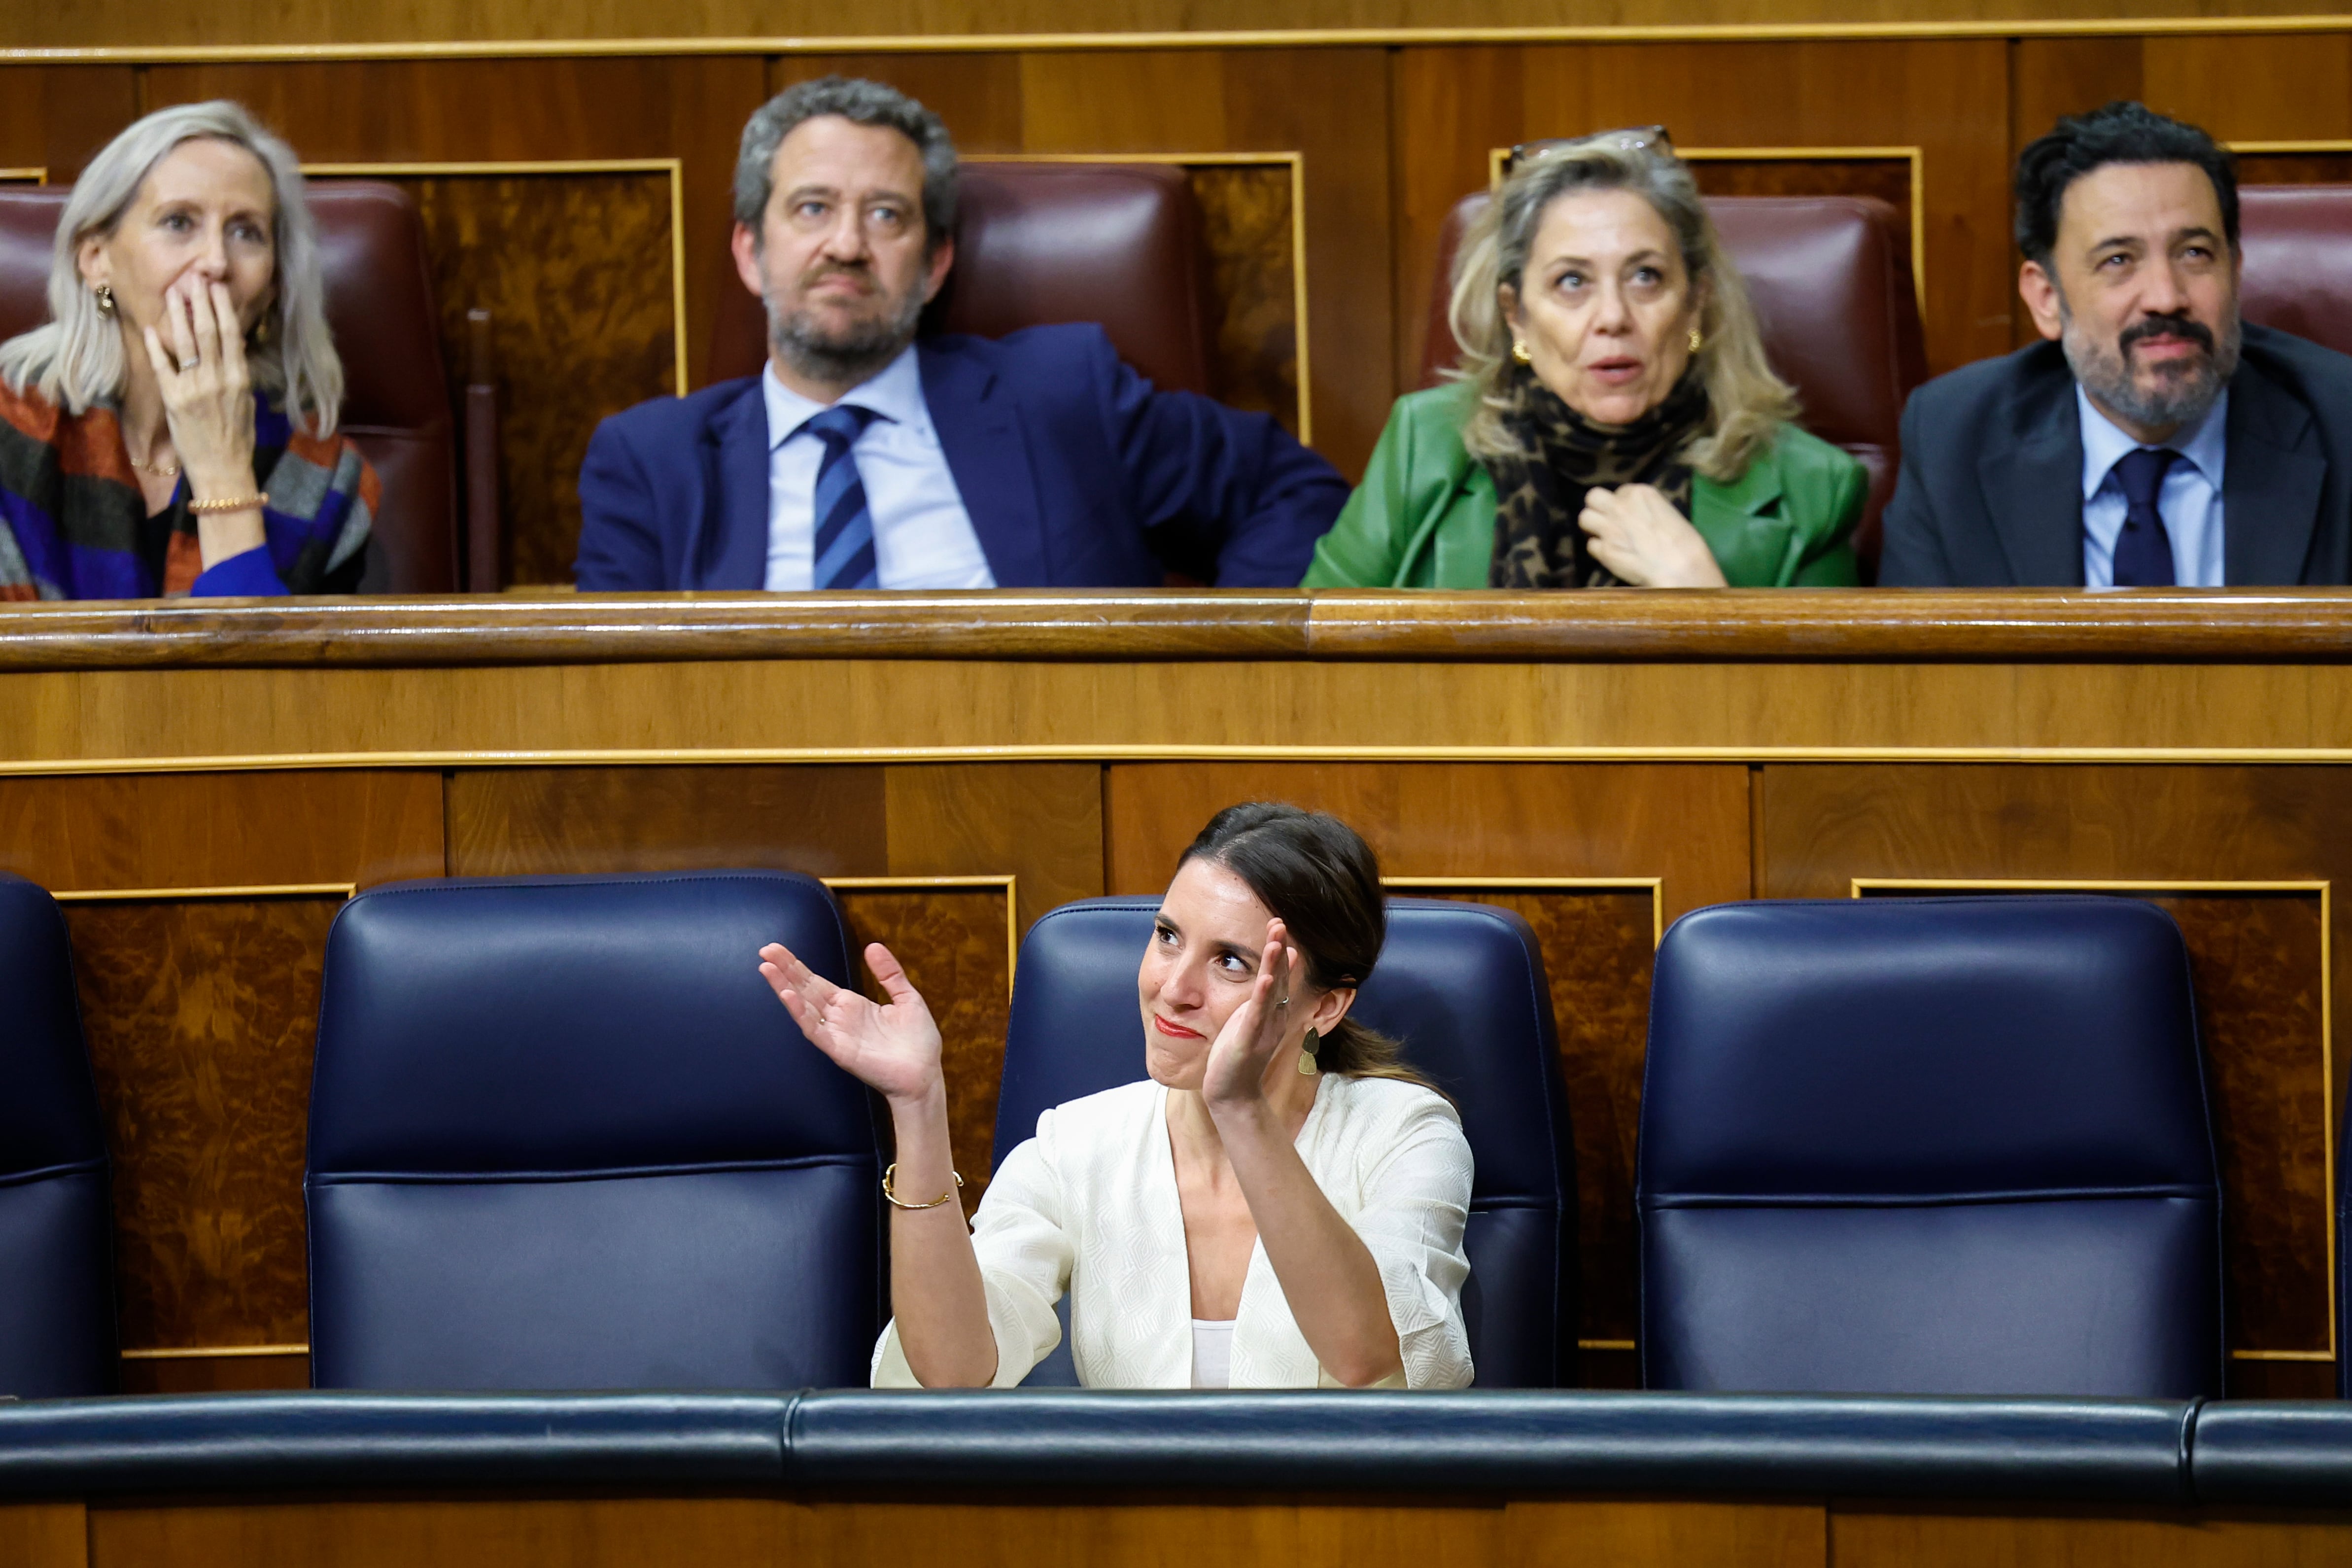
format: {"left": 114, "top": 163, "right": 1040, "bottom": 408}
{"left": 872, "top": 1112, "right": 1075, "bottom": 1390}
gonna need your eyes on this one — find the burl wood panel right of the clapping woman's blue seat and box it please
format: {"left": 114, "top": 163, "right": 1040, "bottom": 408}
{"left": 1399, "top": 889, "right": 1656, "bottom": 1385}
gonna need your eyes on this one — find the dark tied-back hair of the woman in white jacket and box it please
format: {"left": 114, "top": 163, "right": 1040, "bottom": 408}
{"left": 1176, "top": 801, "right": 1428, "bottom": 1084}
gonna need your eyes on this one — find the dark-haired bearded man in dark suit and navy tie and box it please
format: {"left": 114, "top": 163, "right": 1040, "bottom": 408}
{"left": 1879, "top": 104, "right": 2352, "bottom": 588}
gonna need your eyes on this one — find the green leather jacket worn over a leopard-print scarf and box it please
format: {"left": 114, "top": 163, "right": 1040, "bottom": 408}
{"left": 1301, "top": 385, "right": 1870, "bottom": 588}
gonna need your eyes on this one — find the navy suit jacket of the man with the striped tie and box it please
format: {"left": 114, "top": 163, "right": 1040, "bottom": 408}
{"left": 576, "top": 324, "right": 1348, "bottom": 590}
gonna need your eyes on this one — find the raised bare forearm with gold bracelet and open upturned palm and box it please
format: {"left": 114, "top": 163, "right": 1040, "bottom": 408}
{"left": 760, "top": 942, "right": 997, "bottom": 1390}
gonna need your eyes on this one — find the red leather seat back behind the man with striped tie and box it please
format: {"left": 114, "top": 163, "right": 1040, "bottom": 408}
{"left": 708, "top": 162, "right": 1211, "bottom": 392}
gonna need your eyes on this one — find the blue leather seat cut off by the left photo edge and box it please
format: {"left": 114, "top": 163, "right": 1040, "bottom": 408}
{"left": 0, "top": 874, "right": 115, "bottom": 1399}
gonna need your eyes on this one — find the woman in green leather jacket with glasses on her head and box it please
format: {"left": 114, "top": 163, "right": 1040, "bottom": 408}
{"left": 1305, "top": 127, "right": 1868, "bottom": 588}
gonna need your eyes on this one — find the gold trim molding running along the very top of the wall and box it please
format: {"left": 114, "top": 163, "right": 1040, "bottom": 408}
{"left": 14, "top": 14, "right": 2352, "bottom": 66}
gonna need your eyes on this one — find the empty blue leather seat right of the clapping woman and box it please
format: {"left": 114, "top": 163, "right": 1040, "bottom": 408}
{"left": 1635, "top": 896, "right": 2223, "bottom": 1399}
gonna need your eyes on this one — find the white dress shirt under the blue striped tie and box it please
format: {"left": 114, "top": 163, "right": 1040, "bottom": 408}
{"left": 760, "top": 346, "right": 997, "bottom": 590}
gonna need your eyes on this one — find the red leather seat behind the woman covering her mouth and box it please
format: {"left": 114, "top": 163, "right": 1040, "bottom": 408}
{"left": 0, "top": 178, "right": 456, "bottom": 592}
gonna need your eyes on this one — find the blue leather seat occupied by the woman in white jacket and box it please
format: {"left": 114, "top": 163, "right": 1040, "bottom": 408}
{"left": 995, "top": 898, "right": 1576, "bottom": 1387}
